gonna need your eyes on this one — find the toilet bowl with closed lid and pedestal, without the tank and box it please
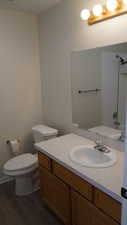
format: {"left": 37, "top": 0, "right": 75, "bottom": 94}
{"left": 3, "top": 153, "right": 38, "bottom": 195}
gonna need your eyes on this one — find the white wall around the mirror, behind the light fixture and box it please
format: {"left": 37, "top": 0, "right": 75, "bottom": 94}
{"left": 40, "top": 0, "right": 127, "bottom": 134}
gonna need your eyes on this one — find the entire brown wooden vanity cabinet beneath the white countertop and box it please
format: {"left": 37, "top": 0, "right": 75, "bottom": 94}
{"left": 38, "top": 153, "right": 121, "bottom": 225}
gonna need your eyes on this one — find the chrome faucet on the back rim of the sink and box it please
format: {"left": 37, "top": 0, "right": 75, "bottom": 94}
{"left": 94, "top": 134, "right": 110, "bottom": 153}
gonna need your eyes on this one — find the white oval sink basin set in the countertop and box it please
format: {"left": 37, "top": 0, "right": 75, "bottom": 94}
{"left": 69, "top": 145, "right": 117, "bottom": 168}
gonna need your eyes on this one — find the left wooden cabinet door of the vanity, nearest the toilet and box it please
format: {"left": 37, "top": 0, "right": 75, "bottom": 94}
{"left": 40, "top": 168, "right": 71, "bottom": 224}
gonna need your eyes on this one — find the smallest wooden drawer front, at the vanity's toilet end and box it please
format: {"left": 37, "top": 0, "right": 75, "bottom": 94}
{"left": 38, "top": 152, "right": 51, "bottom": 171}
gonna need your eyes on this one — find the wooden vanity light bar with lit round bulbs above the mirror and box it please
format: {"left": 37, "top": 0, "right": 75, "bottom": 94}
{"left": 81, "top": 0, "right": 127, "bottom": 25}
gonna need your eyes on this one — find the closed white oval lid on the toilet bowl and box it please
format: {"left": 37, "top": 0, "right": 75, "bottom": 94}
{"left": 4, "top": 153, "right": 38, "bottom": 171}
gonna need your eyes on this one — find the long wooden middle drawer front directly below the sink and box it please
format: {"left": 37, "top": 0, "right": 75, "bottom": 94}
{"left": 53, "top": 161, "right": 93, "bottom": 201}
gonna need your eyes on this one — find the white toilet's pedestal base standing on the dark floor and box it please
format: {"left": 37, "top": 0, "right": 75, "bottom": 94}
{"left": 15, "top": 171, "right": 39, "bottom": 196}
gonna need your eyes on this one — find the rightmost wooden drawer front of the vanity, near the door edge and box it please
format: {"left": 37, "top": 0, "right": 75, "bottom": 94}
{"left": 94, "top": 189, "right": 121, "bottom": 223}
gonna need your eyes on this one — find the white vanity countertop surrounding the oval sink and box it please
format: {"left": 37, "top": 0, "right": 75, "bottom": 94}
{"left": 35, "top": 134, "right": 123, "bottom": 202}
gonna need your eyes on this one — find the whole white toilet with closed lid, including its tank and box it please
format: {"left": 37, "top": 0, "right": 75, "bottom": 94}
{"left": 3, "top": 125, "right": 58, "bottom": 196}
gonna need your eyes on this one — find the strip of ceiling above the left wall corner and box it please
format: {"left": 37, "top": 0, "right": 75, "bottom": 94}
{"left": 0, "top": 0, "right": 61, "bottom": 14}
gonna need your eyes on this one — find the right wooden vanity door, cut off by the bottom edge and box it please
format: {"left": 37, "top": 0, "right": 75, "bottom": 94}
{"left": 72, "top": 191, "right": 118, "bottom": 225}
